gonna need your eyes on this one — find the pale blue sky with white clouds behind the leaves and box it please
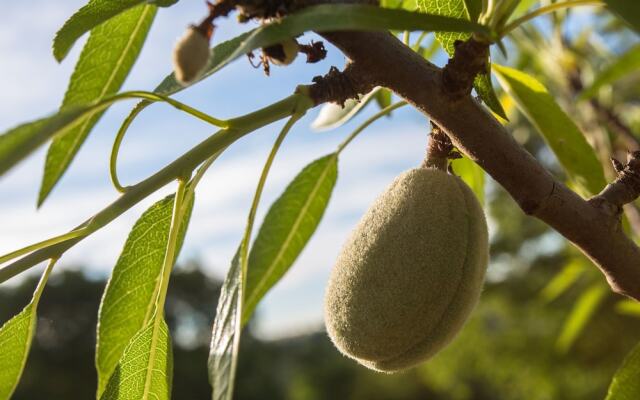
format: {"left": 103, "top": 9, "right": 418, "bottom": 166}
{"left": 0, "top": 0, "right": 436, "bottom": 337}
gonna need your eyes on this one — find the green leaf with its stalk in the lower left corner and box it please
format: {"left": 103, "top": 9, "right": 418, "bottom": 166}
{"left": 0, "top": 261, "right": 55, "bottom": 400}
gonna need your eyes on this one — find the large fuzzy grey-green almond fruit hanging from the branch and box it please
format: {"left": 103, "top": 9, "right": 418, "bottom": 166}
{"left": 325, "top": 168, "right": 489, "bottom": 372}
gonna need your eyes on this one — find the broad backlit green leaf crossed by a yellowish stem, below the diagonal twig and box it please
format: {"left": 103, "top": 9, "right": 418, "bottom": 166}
{"left": 96, "top": 195, "right": 194, "bottom": 396}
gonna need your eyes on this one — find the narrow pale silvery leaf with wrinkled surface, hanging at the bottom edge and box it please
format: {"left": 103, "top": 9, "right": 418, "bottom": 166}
{"left": 208, "top": 248, "right": 242, "bottom": 400}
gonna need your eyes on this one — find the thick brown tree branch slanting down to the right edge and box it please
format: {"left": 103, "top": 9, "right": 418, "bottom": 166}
{"left": 322, "top": 32, "right": 640, "bottom": 300}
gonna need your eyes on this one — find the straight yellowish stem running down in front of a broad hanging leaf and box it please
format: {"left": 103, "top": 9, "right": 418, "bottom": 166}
{"left": 156, "top": 179, "right": 187, "bottom": 315}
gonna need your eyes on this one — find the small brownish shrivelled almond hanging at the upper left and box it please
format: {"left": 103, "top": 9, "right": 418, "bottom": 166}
{"left": 173, "top": 26, "right": 210, "bottom": 85}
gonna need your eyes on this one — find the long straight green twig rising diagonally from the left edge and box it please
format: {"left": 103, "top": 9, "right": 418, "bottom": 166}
{"left": 0, "top": 92, "right": 313, "bottom": 283}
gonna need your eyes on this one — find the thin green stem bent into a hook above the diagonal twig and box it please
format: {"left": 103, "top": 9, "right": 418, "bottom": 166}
{"left": 109, "top": 94, "right": 229, "bottom": 193}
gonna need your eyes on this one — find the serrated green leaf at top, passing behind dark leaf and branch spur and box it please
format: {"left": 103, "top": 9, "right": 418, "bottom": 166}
{"left": 418, "top": 0, "right": 507, "bottom": 120}
